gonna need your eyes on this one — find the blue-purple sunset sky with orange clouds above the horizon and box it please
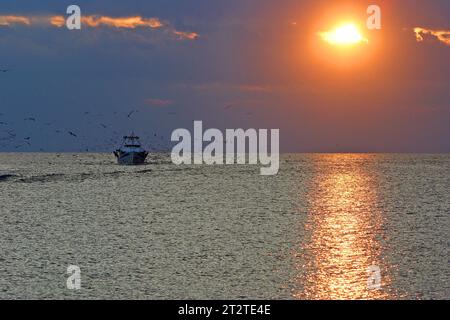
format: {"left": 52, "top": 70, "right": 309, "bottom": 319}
{"left": 0, "top": 0, "right": 450, "bottom": 153}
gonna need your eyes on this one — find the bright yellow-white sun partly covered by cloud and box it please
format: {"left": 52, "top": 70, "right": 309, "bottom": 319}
{"left": 319, "top": 23, "right": 369, "bottom": 46}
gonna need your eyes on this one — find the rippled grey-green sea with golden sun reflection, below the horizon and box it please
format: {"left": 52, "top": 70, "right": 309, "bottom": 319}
{"left": 0, "top": 153, "right": 450, "bottom": 299}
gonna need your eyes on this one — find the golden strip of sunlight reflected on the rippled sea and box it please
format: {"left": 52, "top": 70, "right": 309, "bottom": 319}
{"left": 294, "top": 155, "right": 389, "bottom": 300}
